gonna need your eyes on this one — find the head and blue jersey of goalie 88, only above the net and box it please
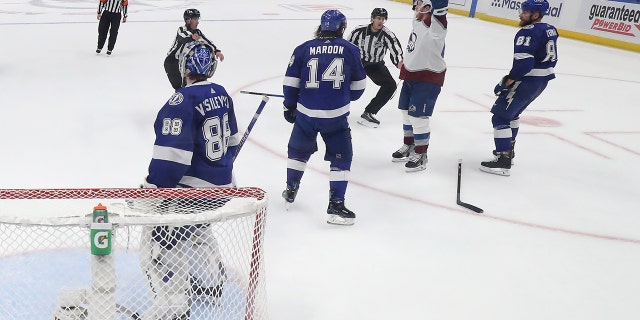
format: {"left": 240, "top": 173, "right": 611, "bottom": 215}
{"left": 147, "top": 41, "right": 240, "bottom": 188}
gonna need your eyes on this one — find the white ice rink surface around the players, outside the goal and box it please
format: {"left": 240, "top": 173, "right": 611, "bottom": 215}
{"left": 0, "top": 0, "right": 640, "bottom": 320}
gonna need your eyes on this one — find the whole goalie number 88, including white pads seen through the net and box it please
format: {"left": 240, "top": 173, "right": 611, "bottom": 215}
{"left": 142, "top": 41, "right": 240, "bottom": 319}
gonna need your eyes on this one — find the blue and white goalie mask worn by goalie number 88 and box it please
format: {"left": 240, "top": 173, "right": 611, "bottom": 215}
{"left": 178, "top": 41, "right": 218, "bottom": 78}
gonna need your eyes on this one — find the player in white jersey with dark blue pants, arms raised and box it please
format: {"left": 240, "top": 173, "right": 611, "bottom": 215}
{"left": 391, "top": 0, "right": 449, "bottom": 172}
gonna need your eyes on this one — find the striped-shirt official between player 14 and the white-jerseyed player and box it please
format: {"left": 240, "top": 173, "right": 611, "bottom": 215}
{"left": 349, "top": 8, "right": 402, "bottom": 128}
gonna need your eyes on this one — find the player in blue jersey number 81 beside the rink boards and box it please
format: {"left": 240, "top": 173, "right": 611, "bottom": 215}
{"left": 480, "top": 0, "right": 558, "bottom": 176}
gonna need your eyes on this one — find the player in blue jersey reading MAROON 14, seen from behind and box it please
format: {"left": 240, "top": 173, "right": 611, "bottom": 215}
{"left": 282, "top": 10, "right": 367, "bottom": 225}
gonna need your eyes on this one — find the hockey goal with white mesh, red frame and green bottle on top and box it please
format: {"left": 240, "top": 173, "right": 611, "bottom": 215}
{"left": 0, "top": 188, "right": 267, "bottom": 320}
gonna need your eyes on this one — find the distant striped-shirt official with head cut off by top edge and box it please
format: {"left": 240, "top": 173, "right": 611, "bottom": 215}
{"left": 96, "top": 0, "right": 129, "bottom": 55}
